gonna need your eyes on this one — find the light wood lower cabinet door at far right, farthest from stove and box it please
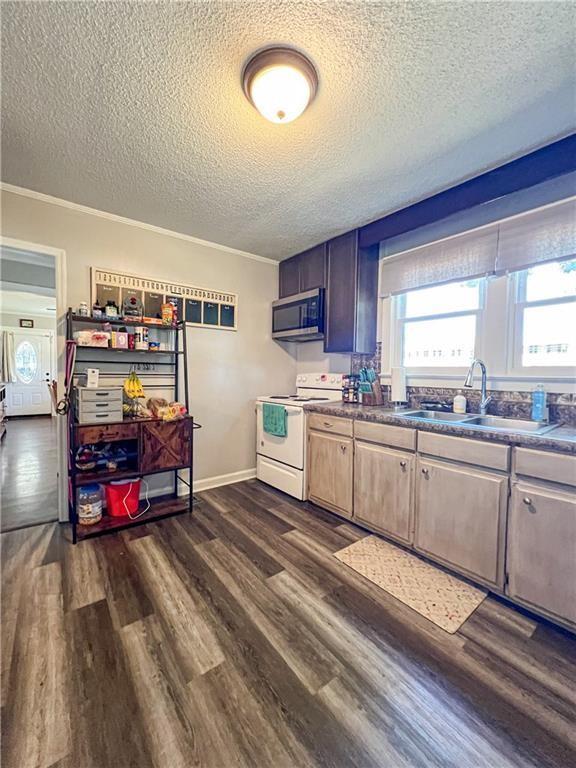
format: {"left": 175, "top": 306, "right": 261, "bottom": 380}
{"left": 506, "top": 482, "right": 576, "bottom": 626}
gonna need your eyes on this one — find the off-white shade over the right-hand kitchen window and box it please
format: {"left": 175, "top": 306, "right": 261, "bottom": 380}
{"left": 496, "top": 200, "right": 576, "bottom": 272}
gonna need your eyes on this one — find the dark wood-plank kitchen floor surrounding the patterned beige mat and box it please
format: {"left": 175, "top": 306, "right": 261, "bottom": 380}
{"left": 1, "top": 481, "right": 576, "bottom": 768}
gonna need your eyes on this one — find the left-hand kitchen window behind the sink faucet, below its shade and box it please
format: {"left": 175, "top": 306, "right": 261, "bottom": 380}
{"left": 394, "top": 279, "right": 485, "bottom": 371}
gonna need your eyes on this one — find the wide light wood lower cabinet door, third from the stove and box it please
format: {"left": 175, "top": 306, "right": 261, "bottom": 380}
{"left": 414, "top": 458, "right": 508, "bottom": 588}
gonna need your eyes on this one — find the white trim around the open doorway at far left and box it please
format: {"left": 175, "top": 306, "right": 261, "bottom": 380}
{"left": 0, "top": 235, "right": 69, "bottom": 522}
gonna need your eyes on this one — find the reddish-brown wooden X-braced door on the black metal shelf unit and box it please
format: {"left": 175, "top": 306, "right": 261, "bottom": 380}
{"left": 140, "top": 419, "right": 192, "bottom": 472}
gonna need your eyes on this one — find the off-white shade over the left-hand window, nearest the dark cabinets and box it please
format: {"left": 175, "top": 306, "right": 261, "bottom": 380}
{"left": 380, "top": 225, "right": 498, "bottom": 296}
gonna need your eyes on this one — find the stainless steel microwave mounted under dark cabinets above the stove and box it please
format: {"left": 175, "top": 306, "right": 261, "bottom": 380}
{"left": 272, "top": 288, "right": 324, "bottom": 341}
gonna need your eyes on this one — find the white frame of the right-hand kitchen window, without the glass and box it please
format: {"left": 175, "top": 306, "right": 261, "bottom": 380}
{"left": 507, "top": 269, "right": 576, "bottom": 379}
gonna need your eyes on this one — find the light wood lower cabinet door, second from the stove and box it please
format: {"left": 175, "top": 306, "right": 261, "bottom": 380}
{"left": 354, "top": 441, "right": 416, "bottom": 544}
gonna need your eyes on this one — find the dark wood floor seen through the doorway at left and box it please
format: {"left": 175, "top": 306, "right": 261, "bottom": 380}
{"left": 0, "top": 416, "right": 58, "bottom": 532}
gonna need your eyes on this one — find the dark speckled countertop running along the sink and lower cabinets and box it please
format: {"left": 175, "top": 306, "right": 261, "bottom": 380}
{"left": 304, "top": 402, "right": 576, "bottom": 454}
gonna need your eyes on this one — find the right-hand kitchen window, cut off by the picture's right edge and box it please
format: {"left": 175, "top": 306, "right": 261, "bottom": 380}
{"left": 513, "top": 260, "right": 576, "bottom": 375}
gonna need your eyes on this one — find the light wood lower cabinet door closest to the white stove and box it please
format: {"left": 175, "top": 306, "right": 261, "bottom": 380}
{"left": 308, "top": 430, "right": 354, "bottom": 517}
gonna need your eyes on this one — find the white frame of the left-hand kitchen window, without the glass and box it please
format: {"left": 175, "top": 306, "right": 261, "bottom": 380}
{"left": 390, "top": 277, "right": 487, "bottom": 378}
